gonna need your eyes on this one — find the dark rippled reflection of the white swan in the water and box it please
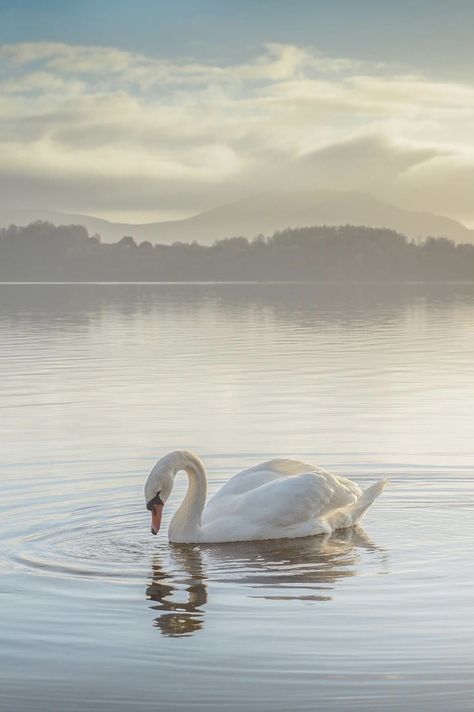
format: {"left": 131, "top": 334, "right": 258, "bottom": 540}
{"left": 146, "top": 527, "right": 386, "bottom": 637}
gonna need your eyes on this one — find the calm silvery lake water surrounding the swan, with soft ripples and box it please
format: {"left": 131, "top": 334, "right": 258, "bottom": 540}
{"left": 0, "top": 285, "right": 474, "bottom": 712}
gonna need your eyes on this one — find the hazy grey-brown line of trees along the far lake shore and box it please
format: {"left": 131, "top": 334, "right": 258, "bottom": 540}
{"left": 0, "top": 221, "right": 474, "bottom": 282}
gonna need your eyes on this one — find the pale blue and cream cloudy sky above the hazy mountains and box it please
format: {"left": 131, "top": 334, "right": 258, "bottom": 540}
{"left": 0, "top": 0, "right": 474, "bottom": 225}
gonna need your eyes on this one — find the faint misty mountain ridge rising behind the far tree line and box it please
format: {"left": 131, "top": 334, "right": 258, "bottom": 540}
{"left": 0, "top": 190, "right": 474, "bottom": 244}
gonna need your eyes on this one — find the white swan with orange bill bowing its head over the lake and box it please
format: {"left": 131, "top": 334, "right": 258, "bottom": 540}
{"left": 145, "top": 450, "right": 387, "bottom": 544}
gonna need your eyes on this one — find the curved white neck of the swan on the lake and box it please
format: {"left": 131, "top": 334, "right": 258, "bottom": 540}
{"left": 169, "top": 450, "right": 207, "bottom": 543}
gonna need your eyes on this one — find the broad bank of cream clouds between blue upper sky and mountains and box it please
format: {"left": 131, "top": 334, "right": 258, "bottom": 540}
{"left": 0, "top": 43, "right": 474, "bottom": 219}
